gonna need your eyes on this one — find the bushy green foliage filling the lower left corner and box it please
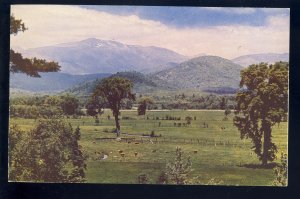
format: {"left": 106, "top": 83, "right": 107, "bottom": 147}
{"left": 9, "top": 120, "right": 86, "bottom": 182}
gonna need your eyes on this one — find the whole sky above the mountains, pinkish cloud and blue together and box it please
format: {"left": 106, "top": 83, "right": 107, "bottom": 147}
{"left": 11, "top": 5, "right": 290, "bottom": 59}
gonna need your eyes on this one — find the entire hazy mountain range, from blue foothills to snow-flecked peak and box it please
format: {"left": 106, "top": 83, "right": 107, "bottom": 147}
{"left": 10, "top": 38, "right": 289, "bottom": 93}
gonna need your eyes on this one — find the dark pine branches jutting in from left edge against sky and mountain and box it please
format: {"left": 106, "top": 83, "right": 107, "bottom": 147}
{"left": 9, "top": 15, "right": 61, "bottom": 77}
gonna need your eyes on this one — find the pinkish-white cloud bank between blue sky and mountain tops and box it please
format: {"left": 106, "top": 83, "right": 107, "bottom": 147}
{"left": 11, "top": 5, "right": 289, "bottom": 58}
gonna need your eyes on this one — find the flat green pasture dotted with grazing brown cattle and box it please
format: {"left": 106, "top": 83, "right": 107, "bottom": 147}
{"left": 11, "top": 110, "right": 287, "bottom": 186}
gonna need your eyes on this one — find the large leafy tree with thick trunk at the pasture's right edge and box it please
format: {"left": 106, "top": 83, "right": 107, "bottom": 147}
{"left": 234, "top": 62, "right": 289, "bottom": 166}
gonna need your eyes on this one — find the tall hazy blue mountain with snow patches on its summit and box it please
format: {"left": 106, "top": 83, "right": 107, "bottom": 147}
{"left": 21, "top": 38, "right": 188, "bottom": 74}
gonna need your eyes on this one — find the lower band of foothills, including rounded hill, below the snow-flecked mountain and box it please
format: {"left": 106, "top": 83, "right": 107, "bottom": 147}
{"left": 10, "top": 56, "right": 242, "bottom": 93}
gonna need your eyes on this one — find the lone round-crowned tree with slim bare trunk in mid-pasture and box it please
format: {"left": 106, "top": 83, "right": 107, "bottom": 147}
{"left": 91, "top": 77, "right": 135, "bottom": 136}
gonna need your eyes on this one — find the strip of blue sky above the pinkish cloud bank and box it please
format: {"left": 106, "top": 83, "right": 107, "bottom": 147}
{"left": 81, "top": 5, "right": 289, "bottom": 28}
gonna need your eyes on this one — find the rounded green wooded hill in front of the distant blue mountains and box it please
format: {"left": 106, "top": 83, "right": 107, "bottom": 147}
{"left": 153, "top": 56, "right": 242, "bottom": 89}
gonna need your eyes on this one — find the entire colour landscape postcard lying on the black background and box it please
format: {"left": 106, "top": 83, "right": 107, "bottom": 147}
{"left": 8, "top": 5, "right": 290, "bottom": 186}
